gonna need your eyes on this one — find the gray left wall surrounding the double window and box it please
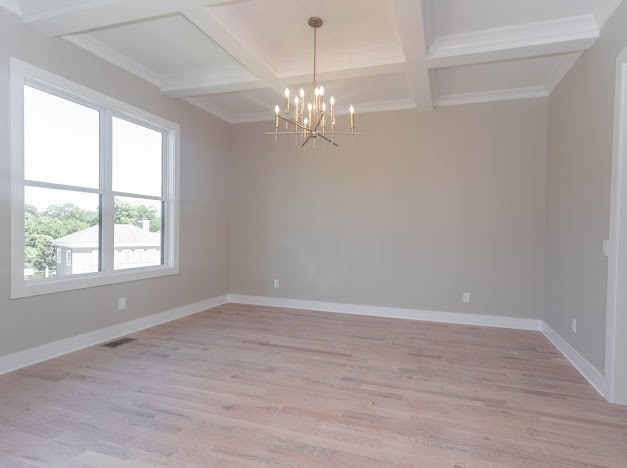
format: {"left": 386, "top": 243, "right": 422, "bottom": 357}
{"left": 0, "top": 9, "right": 230, "bottom": 356}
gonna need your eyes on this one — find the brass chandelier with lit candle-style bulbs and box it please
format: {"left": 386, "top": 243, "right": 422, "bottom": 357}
{"left": 266, "top": 16, "right": 362, "bottom": 147}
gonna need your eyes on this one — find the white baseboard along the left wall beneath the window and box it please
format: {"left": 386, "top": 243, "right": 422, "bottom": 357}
{"left": 0, "top": 296, "right": 227, "bottom": 375}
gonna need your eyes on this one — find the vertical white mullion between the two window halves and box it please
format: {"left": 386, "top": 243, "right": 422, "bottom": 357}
{"left": 100, "top": 109, "right": 115, "bottom": 271}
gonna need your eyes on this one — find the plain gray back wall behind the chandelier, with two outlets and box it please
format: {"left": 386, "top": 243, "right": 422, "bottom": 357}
{"left": 229, "top": 99, "right": 548, "bottom": 318}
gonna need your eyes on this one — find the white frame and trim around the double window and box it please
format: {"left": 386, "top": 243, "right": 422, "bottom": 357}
{"left": 10, "top": 57, "right": 180, "bottom": 299}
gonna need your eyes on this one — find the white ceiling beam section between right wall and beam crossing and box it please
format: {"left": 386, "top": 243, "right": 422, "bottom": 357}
{"left": 427, "top": 15, "right": 599, "bottom": 68}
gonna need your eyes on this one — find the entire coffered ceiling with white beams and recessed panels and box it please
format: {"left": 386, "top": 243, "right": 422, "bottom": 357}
{"left": 0, "top": 0, "right": 621, "bottom": 123}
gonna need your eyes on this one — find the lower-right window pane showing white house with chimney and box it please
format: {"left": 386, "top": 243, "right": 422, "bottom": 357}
{"left": 113, "top": 197, "right": 163, "bottom": 270}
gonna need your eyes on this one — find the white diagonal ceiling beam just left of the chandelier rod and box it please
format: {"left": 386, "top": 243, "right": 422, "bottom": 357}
{"left": 181, "top": 8, "right": 285, "bottom": 96}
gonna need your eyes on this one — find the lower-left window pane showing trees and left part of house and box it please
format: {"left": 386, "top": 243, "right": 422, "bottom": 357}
{"left": 24, "top": 187, "right": 100, "bottom": 279}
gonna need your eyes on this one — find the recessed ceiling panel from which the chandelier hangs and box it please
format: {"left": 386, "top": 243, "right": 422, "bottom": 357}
{"left": 207, "top": 0, "right": 399, "bottom": 73}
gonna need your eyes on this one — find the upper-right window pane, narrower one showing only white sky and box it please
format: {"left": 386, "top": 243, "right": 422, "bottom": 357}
{"left": 112, "top": 117, "right": 163, "bottom": 197}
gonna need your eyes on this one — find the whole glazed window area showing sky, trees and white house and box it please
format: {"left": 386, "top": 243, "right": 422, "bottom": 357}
{"left": 24, "top": 84, "right": 168, "bottom": 280}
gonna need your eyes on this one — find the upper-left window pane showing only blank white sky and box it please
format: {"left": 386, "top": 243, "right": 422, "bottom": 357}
{"left": 24, "top": 86, "right": 100, "bottom": 188}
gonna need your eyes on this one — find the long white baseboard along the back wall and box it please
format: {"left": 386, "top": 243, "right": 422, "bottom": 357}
{"left": 227, "top": 294, "right": 542, "bottom": 330}
